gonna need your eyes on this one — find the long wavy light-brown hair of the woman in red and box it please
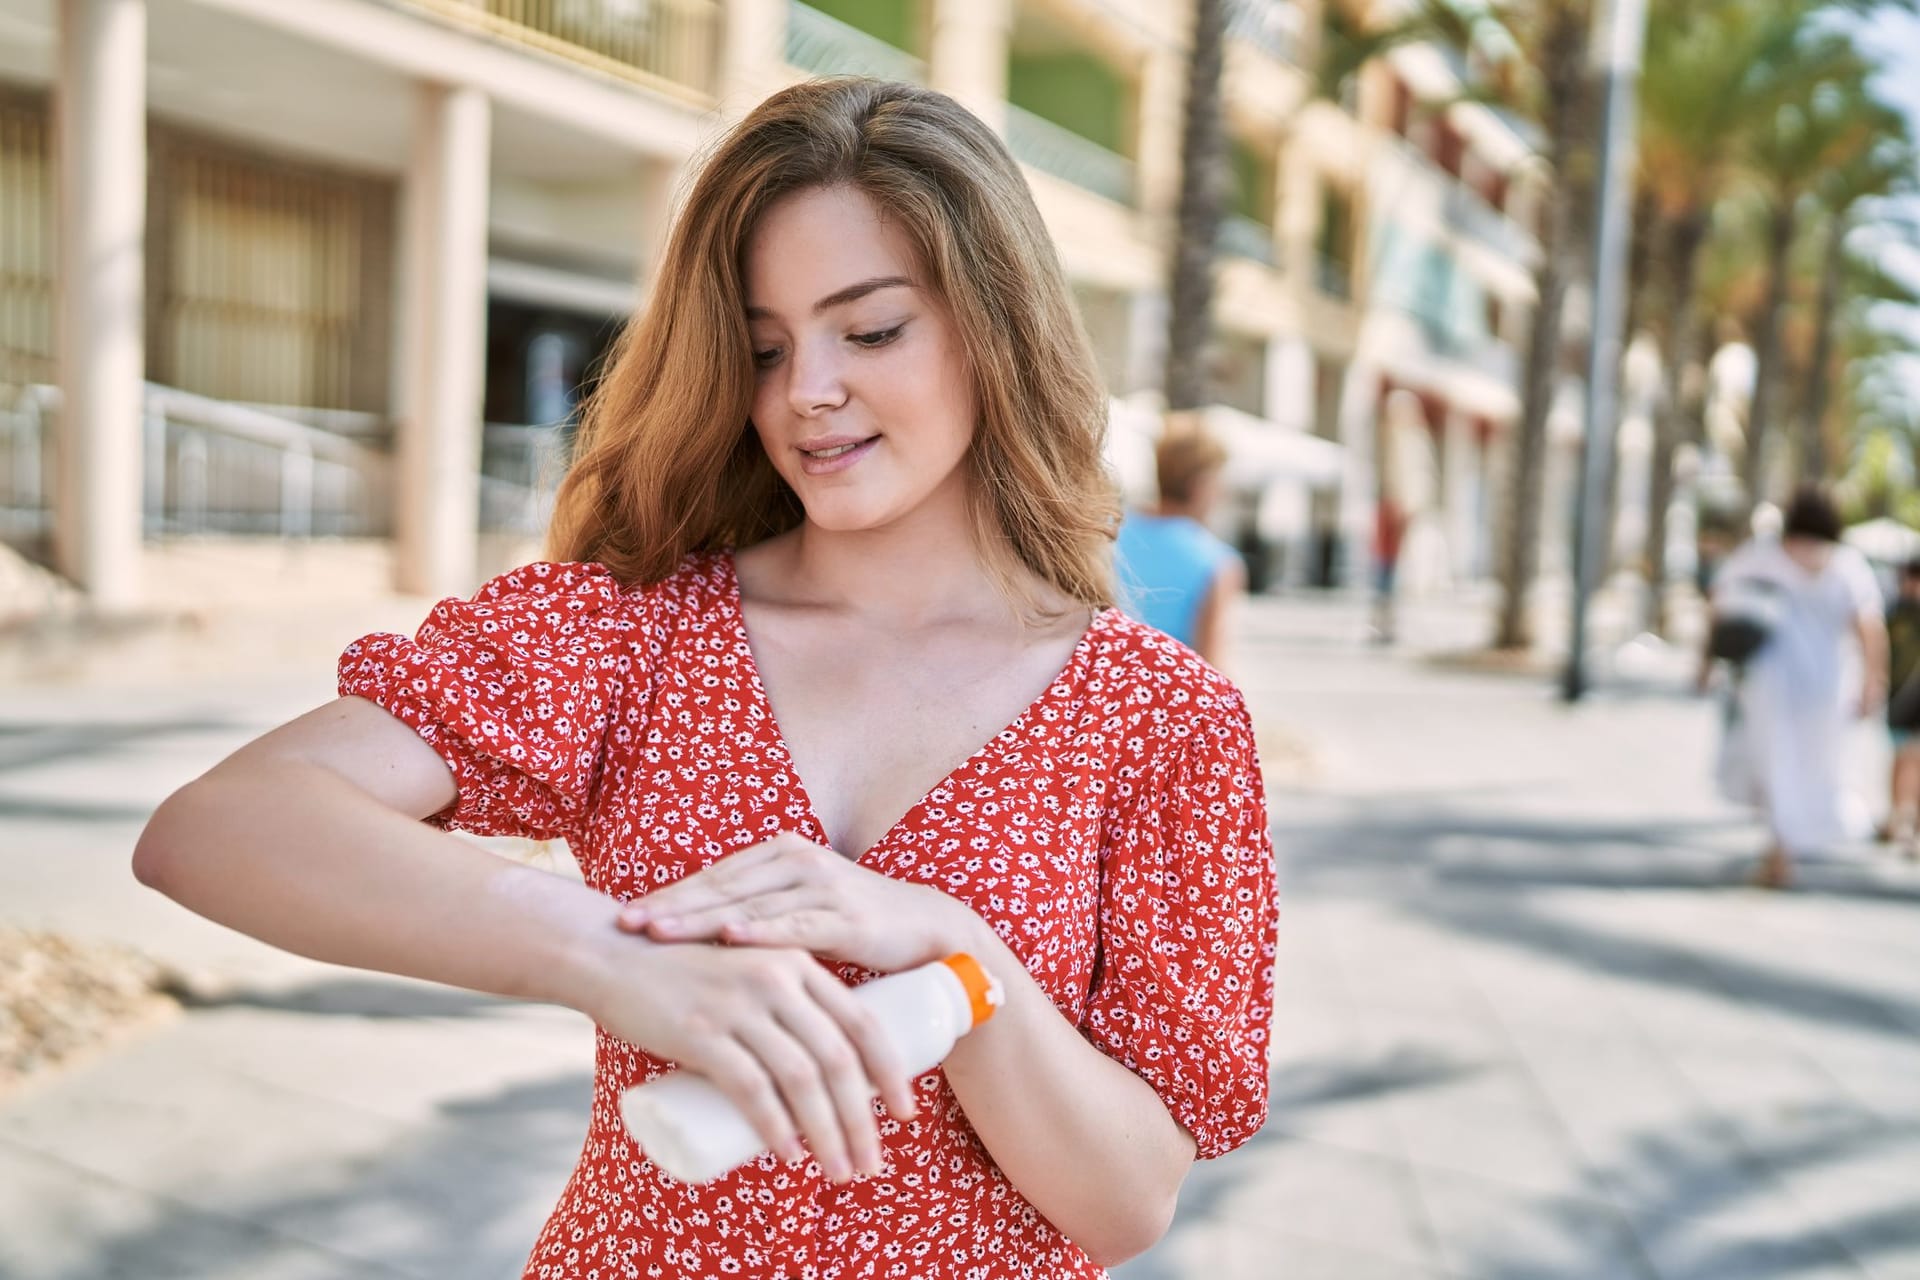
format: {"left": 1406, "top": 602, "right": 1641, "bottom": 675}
{"left": 547, "top": 79, "right": 1119, "bottom": 612}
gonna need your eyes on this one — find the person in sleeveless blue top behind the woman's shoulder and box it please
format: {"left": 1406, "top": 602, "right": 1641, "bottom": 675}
{"left": 1114, "top": 424, "right": 1246, "bottom": 668}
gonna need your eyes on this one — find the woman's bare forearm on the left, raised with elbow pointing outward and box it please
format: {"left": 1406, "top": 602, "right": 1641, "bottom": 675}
{"left": 134, "top": 760, "right": 618, "bottom": 1009}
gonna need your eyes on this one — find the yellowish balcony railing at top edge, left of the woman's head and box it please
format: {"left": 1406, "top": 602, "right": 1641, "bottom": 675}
{"left": 390, "top": 0, "right": 722, "bottom": 102}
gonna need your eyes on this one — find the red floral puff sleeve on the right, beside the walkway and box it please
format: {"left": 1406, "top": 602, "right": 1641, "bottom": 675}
{"left": 1081, "top": 693, "right": 1275, "bottom": 1159}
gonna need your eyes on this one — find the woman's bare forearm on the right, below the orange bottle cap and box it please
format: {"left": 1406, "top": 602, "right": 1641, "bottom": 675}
{"left": 945, "top": 929, "right": 1194, "bottom": 1267}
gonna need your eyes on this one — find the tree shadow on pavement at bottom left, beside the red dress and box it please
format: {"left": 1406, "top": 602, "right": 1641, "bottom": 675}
{"left": 33, "top": 1073, "right": 591, "bottom": 1280}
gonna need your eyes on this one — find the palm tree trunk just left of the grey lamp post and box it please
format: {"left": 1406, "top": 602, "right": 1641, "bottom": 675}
{"left": 1494, "top": 6, "right": 1594, "bottom": 649}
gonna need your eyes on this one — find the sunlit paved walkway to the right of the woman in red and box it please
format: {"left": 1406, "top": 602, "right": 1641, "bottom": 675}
{"left": 1117, "top": 601, "right": 1920, "bottom": 1280}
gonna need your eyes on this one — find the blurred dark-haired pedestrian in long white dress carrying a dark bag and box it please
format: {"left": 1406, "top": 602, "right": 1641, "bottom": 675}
{"left": 1701, "top": 487, "right": 1887, "bottom": 889}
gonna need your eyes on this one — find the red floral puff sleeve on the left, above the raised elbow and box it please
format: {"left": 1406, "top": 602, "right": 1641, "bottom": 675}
{"left": 340, "top": 564, "right": 645, "bottom": 841}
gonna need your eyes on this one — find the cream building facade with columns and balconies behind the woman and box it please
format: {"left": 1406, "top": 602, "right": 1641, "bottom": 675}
{"left": 0, "top": 0, "right": 1538, "bottom": 610}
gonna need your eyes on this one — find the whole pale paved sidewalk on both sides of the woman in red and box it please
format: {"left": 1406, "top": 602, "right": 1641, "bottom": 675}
{"left": 0, "top": 601, "right": 1920, "bottom": 1280}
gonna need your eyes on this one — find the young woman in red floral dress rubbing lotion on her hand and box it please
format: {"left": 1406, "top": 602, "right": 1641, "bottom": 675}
{"left": 134, "top": 81, "right": 1275, "bottom": 1278}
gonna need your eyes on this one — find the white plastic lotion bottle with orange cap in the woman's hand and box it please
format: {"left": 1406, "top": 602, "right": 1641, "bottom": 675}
{"left": 620, "top": 952, "right": 1004, "bottom": 1182}
